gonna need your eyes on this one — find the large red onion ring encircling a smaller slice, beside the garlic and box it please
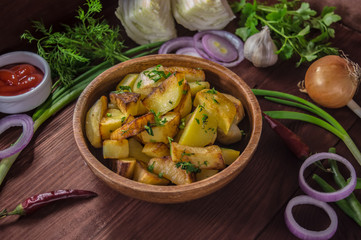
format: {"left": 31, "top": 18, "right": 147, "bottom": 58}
{"left": 193, "top": 30, "right": 244, "bottom": 67}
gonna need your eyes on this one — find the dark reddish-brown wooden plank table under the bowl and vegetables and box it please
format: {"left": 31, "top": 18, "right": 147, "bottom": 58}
{"left": 0, "top": 0, "right": 361, "bottom": 240}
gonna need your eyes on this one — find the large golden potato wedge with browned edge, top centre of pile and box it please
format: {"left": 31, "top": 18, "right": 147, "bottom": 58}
{"left": 143, "top": 73, "right": 186, "bottom": 115}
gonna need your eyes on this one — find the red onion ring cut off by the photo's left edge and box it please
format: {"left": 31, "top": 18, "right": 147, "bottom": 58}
{"left": 0, "top": 114, "right": 34, "bottom": 159}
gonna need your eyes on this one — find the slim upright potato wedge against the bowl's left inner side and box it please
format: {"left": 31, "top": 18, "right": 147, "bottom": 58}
{"left": 85, "top": 96, "right": 108, "bottom": 148}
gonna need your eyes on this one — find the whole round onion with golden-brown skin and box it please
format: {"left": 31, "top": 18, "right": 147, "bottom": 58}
{"left": 305, "top": 55, "right": 358, "bottom": 108}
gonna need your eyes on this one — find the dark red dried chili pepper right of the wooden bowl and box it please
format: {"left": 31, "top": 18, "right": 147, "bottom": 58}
{"left": 262, "top": 113, "right": 311, "bottom": 160}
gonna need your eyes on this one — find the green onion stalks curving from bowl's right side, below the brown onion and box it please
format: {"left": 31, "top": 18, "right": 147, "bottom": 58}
{"left": 252, "top": 89, "right": 361, "bottom": 166}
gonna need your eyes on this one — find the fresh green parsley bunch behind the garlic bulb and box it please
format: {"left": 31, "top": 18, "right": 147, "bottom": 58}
{"left": 232, "top": 0, "right": 341, "bottom": 66}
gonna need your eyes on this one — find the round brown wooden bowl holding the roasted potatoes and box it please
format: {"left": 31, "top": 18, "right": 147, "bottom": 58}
{"left": 73, "top": 55, "right": 262, "bottom": 203}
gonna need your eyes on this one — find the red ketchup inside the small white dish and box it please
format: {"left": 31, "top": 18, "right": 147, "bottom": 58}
{"left": 0, "top": 64, "right": 44, "bottom": 96}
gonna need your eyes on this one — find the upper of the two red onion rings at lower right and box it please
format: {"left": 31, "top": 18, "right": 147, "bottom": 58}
{"left": 298, "top": 153, "right": 356, "bottom": 202}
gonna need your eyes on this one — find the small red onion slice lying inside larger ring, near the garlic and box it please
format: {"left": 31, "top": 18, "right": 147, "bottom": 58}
{"left": 202, "top": 33, "right": 238, "bottom": 62}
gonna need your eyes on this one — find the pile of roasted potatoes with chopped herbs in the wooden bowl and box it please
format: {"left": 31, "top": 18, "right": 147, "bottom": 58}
{"left": 85, "top": 65, "right": 245, "bottom": 185}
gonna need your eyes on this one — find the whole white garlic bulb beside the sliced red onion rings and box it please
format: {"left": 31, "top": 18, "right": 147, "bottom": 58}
{"left": 243, "top": 26, "right": 278, "bottom": 67}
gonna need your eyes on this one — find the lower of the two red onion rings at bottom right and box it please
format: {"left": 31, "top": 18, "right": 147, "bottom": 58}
{"left": 284, "top": 195, "right": 338, "bottom": 240}
